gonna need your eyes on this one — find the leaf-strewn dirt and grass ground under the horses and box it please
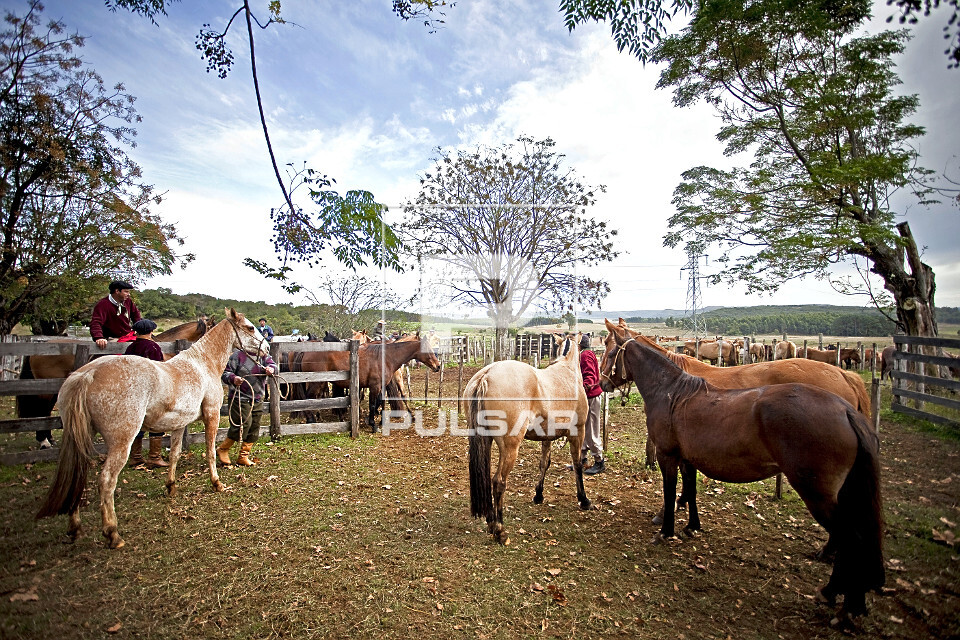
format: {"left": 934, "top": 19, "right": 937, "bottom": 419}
{"left": 0, "top": 362, "right": 960, "bottom": 640}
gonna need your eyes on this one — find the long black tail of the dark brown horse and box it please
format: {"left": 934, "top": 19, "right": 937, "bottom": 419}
{"left": 831, "top": 409, "right": 886, "bottom": 593}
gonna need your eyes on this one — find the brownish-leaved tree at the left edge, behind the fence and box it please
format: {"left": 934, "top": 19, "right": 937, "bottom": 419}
{"left": 0, "top": 2, "right": 192, "bottom": 335}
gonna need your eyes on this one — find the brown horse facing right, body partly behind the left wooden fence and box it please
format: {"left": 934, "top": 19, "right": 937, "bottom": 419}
{"left": 290, "top": 338, "right": 440, "bottom": 427}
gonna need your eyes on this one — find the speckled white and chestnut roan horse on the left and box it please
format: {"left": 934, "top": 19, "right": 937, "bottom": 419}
{"left": 37, "top": 309, "right": 269, "bottom": 549}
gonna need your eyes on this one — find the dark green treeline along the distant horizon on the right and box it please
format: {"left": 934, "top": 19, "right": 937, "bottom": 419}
{"left": 627, "top": 305, "right": 960, "bottom": 336}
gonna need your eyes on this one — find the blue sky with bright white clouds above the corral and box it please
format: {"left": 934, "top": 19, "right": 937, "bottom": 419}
{"left": 26, "top": 0, "right": 960, "bottom": 310}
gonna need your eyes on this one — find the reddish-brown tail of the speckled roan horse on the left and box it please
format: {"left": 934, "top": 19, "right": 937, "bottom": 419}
{"left": 37, "top": 372, "right": 96, "bottom": 519}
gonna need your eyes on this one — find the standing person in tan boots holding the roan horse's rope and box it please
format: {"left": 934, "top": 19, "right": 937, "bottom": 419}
{"left": 217, "top": 349, "right": 277, "bottom": 467}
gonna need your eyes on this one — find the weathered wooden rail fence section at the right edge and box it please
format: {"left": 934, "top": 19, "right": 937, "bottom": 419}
{"left": 890, "top": 336, "right": 960, "bottom": 427}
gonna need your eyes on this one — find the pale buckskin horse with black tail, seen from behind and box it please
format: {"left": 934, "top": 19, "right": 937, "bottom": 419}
{"left": 464, "top": 341, "right": 590, "bottom": 544}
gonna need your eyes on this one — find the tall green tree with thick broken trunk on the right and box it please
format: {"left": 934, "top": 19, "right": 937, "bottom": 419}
{"left": 653, "top": 0, "right": 937, "bottom": 335}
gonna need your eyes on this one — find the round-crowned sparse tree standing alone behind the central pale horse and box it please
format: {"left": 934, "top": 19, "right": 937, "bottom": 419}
{"left": 400, "top": 137, "right": 617, "bottom": 357}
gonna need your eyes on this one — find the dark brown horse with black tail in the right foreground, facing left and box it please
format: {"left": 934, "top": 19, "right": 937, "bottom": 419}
{"left": 601, "top": 333, "right": 884, "bottom": 624}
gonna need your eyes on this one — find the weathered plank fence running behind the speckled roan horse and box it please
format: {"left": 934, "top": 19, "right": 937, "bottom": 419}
{"left": 0, "top": 340, "right": 360, "bottom": 465}
